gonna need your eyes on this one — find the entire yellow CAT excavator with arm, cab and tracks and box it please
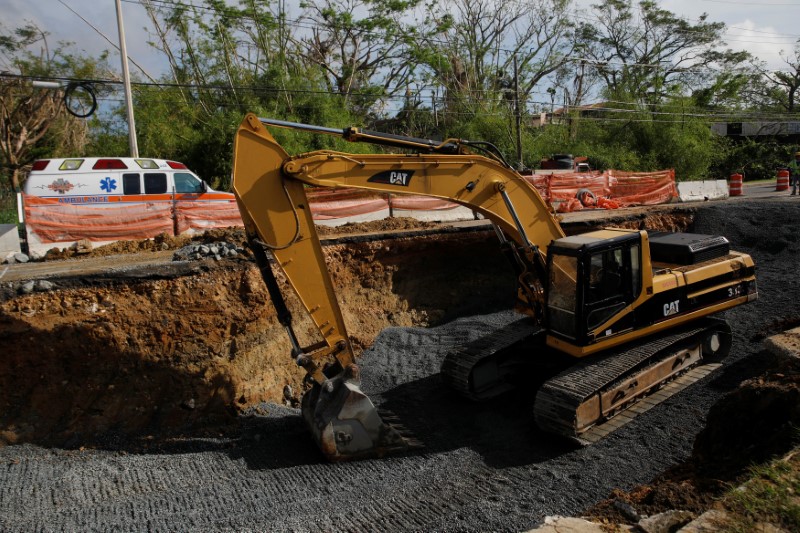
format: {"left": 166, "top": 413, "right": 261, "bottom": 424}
{"left": 233, "top": 114, "right": 758, "bottom": 461}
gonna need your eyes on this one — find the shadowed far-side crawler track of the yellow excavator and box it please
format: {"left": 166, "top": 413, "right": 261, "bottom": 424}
{"left": 441, "top": 317, "right": 540, "bottom": 401}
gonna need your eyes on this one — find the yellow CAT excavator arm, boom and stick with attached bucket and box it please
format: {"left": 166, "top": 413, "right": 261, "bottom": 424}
{"left": 233, "top": 114, "right": 564, "bottom": 460}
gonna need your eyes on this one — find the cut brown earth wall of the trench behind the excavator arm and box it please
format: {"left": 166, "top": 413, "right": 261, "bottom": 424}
{"left": 0, "top": 211, "right": 693, "bottom": 447}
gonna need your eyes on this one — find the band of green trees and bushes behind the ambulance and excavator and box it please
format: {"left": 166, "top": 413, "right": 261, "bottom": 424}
{"left": 9, "top": 0, "right": 796, "bottom": 188}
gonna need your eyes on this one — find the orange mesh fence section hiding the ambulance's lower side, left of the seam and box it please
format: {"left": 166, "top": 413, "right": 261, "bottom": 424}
{"left": 24, "top": 195, "right": 173, "bottom": 243}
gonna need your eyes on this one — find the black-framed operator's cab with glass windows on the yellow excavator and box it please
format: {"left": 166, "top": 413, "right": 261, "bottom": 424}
{"left": 545, "top": 230, "right": 642, "bottom": 346}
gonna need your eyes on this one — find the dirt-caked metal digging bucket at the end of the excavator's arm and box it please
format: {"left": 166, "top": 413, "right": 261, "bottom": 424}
{"left": 302, "top": 365, "right": 420, "bottom": 461}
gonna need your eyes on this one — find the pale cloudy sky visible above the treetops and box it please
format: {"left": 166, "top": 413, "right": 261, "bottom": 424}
{"left": 0, "top": 0, "right": 800, "bottom": 84}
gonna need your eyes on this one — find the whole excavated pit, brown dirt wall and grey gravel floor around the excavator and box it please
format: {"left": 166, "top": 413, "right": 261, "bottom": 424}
{"left": 0, "top": 201, "right": 800, "bottom": 532}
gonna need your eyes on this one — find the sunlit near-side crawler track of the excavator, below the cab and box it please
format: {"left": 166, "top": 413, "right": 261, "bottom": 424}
{"left": 534, "top": 319, "right": 731, "bottom": 443}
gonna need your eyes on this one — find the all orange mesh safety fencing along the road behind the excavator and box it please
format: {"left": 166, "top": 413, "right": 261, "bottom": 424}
{"left": 23, "top": 170, "right": 678, "bottom": 243}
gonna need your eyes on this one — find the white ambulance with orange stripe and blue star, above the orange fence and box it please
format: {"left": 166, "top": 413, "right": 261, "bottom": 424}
{"left": 24, "top": 157, "right": 236, "bottom": 205}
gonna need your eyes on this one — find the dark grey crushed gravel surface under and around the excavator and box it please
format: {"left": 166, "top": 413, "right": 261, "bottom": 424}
{"left": 0, "top": 197, "right": 800, "bottom": 531}
